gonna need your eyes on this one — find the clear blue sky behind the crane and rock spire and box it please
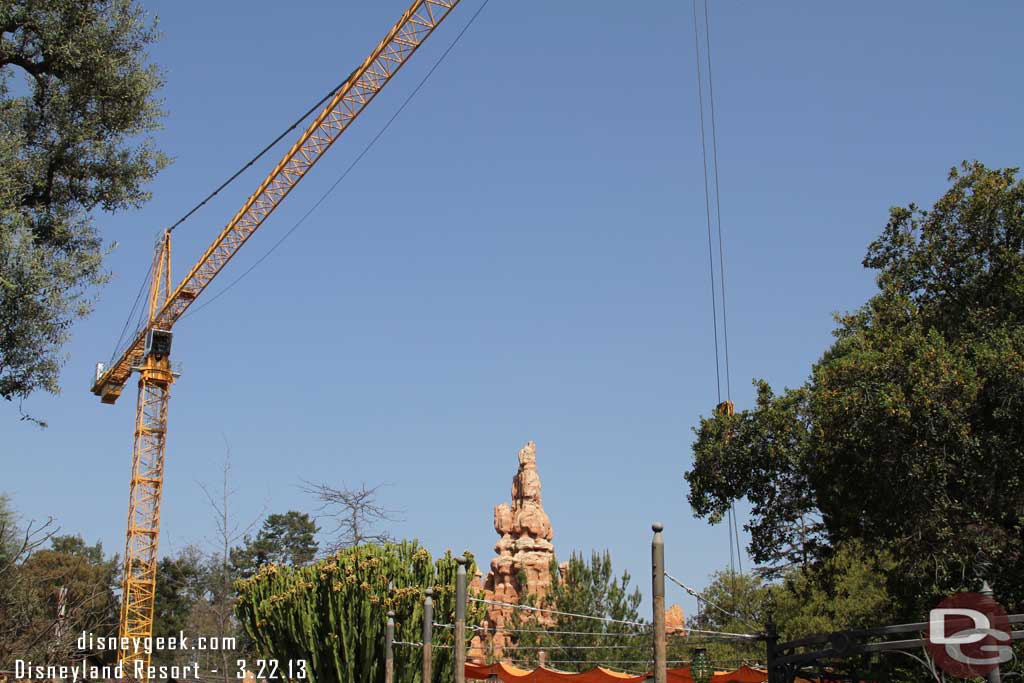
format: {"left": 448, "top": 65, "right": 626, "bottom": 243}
{"left": 6, "top": 0, "right": 1024, "bottom": 612}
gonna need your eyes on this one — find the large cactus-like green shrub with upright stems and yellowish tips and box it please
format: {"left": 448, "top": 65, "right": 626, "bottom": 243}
{"left": 237, "top": 541, "right": 483, "bottom": 683}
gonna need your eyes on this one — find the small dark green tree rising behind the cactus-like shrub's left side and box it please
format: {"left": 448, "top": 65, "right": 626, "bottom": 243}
{"left": 231, "top": 510, "right": 319, "bottom": 577}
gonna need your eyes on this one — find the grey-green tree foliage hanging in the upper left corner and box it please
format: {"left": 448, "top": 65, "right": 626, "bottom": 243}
{"left": 0, "top": 0, "right": 167, "bottom": 400}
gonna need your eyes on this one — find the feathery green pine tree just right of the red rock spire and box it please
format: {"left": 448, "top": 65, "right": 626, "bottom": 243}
{"left": 512, "top": 551, "right": 651, "bottom": 671}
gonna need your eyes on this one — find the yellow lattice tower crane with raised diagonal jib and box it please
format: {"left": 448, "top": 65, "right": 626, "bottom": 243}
{"left": 92, "top": 0, "right": 460, "bottom": 678}
